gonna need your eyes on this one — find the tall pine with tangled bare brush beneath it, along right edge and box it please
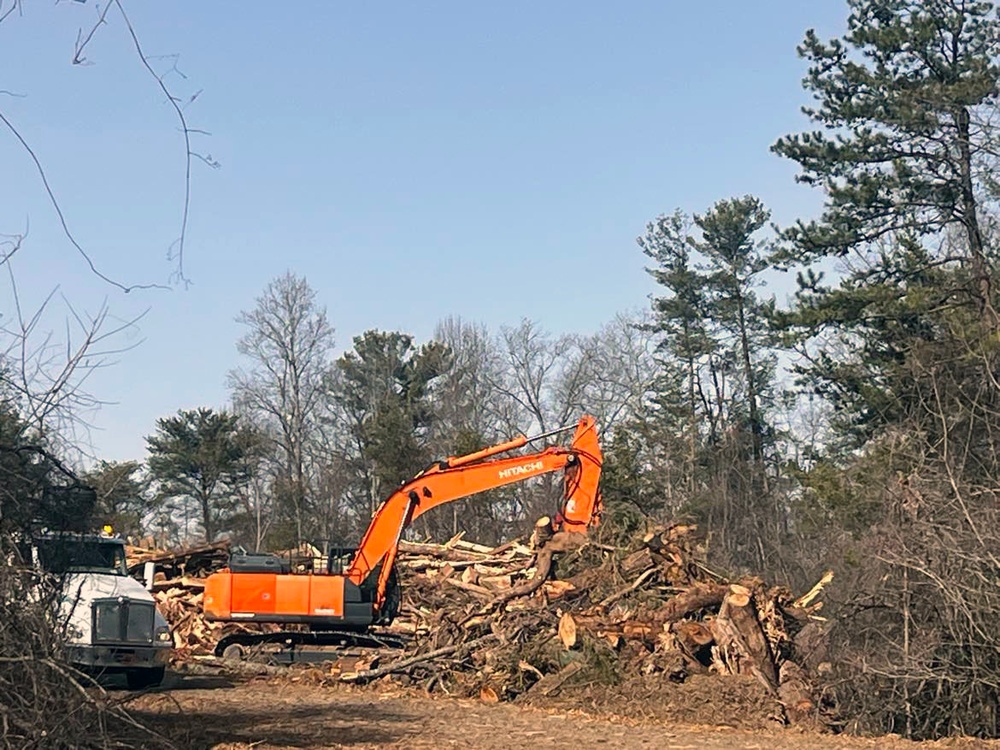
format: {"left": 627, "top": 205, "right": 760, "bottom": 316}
{"left": 774, "top": 0, "right": 1000, "bottom": 737}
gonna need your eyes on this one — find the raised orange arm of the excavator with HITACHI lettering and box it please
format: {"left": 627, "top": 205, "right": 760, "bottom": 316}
{"left": 346, "top": 416, "right": 602, "bottom": 611}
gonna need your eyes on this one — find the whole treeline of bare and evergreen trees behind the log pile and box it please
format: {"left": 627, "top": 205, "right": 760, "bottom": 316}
{"left": 0, "top": 0, "right": 1000, "bottom": 737}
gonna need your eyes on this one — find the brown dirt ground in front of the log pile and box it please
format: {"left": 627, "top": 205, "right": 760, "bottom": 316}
{"left": 129, "top": 674, "right": 1000, "bottom": 750}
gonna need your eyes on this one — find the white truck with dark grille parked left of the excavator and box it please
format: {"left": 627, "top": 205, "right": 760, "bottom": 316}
{"left": 31, "top": 533, "right": 173, "bottom": 690}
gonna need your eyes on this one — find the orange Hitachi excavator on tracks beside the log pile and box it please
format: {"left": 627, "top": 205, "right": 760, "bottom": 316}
{"left": 203, "top": 416, "right": 602, "bottom": 657}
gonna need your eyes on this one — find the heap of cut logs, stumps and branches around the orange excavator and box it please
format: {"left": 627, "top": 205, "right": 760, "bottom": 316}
{"left": 127, "top": 519, "right": 829, "bottom": 723}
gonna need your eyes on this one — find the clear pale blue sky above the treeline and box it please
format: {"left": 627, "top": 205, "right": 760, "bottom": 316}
{"left": 0, "top": 0, "right": 846, "bottom": 459}
